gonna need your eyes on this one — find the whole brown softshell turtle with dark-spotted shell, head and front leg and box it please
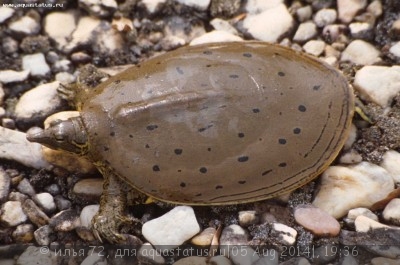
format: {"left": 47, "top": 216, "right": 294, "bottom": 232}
{"left": 27, "top": 42, "right": 354, "bottom": 242}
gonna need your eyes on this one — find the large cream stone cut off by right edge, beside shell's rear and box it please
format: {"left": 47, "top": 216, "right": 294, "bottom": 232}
{"left": 354, "top": 65, "right": 400, "bottom": 108}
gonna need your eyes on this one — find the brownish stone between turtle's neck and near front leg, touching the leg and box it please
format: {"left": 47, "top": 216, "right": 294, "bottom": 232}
{"left": 72, "top": 178, "right": 103, "bottom": 202}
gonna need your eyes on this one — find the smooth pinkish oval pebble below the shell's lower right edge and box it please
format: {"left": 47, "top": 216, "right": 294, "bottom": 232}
{"left": 294, "top": 205, "right": 340, "bottom": 236}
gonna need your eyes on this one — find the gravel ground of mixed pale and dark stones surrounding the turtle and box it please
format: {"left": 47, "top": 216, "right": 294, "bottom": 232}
{"left": 0, "top": 0, "right": 400, "bottom": 265}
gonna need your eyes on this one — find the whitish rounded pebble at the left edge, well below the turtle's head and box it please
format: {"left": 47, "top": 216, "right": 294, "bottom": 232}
{"left": 0, "top": 201, "right": 28, "bottom": 227}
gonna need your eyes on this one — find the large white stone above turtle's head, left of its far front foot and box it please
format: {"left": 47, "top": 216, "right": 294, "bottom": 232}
{"left": 15, "top": 81, "right": 61, "bottom": 119}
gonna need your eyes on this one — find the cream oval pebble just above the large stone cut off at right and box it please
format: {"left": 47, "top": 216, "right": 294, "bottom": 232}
{"left": 340, "top": 40, "right": 381, "bottom": 65}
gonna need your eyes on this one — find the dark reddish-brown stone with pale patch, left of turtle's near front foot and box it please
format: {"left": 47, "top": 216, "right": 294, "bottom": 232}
{"left": 49, "top": 210, "right": 81, "bottom": 232}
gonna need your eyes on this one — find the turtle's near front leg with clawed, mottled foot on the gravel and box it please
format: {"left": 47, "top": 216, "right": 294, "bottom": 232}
{"left": 92, "top": 169, "right": 145, "bottom": 244}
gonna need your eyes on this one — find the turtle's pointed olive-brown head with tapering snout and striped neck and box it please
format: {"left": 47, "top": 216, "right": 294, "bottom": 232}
{"left": 26, "top": 117, "right": 88, "bottom": 155}
